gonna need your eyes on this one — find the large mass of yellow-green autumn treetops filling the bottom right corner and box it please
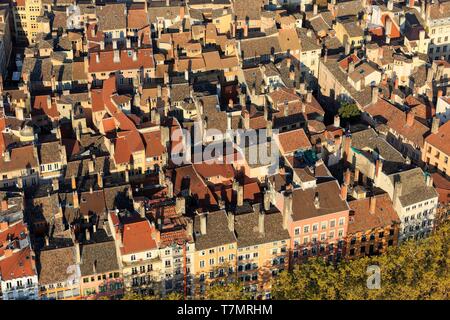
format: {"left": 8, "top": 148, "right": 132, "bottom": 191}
{"left": 272, "top": 223, "right": 450, "bottom": 300}
